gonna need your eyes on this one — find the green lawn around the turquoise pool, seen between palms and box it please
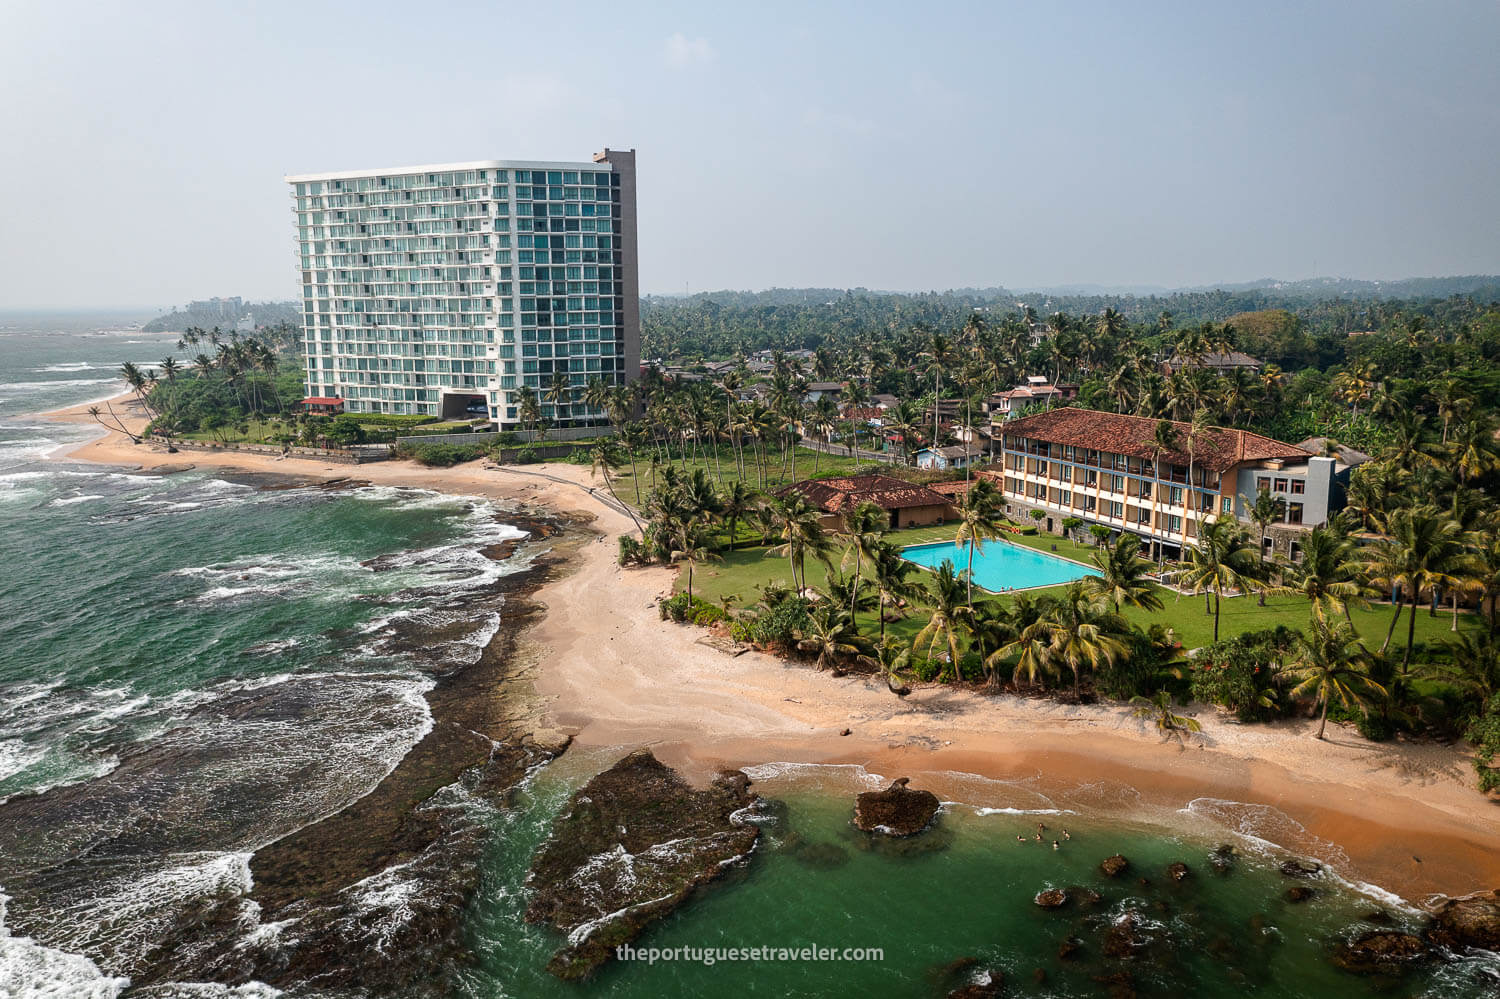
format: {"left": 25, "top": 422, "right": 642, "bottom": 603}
{"left": 677, "top": 525, "right": 1481, "bottom": 648}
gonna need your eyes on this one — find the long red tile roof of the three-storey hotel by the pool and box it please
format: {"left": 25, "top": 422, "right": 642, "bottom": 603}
{"left": 1005, "top": 410, "right": 1310, "bottom": 471}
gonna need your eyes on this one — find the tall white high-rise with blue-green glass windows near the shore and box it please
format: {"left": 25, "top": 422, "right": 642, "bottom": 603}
{"left": 287, "top": 149, "right": 641, "bottom": 429}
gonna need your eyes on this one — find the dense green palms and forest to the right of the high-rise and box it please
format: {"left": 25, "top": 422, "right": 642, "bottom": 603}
{"left": 599, "top": 291, "right": 1500, "bottom": 788}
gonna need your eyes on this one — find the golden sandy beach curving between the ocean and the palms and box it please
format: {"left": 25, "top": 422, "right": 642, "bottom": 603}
{"left": 47, "top": 398, "right": 1500, "bottom": 902}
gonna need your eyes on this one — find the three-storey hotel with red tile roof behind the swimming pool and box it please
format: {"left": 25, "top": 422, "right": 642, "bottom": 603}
{"left": 992, "top": 408, "right": 1347, "bottom": 558}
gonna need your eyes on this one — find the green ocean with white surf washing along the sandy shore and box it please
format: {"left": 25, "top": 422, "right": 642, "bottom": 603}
{"left": 0, "top": 317, "right": 1500, "bottom": 999}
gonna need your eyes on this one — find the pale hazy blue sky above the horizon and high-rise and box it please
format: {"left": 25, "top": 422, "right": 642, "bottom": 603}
{"left": 0, "top": 0, "right": 1500, "bottom": 308}
